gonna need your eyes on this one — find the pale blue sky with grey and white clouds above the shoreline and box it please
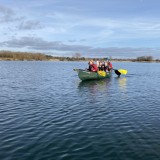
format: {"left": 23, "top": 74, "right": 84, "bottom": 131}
{"left": 0, "top": 0, "right": 160, "bottom": 58}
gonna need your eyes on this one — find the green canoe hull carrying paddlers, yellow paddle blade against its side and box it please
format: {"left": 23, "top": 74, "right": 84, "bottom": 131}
{"left": 74, "top": 69, "right": 111, "bottom": 81}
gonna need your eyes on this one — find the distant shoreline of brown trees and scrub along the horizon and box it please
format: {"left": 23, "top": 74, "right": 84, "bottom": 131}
{"left": 0, "top": 51, "right": 160, "bottom": 63}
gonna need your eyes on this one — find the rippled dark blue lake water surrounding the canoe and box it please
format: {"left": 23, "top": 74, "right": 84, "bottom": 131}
{"left": 0, "top": 62, "right": 160, "bottom": 160}
